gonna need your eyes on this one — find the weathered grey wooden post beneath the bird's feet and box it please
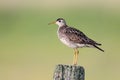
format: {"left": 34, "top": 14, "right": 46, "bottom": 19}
{"left": 53, "top": 64, "right": 85, "bottom": 80}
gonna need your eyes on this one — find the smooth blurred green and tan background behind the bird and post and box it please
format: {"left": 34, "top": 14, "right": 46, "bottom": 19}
{"left": 0, "top": 0, "right": 120, "bottom": 80}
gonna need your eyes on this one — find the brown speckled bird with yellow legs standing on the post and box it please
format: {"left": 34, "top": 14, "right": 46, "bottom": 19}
{"left": 49, "top": 18, "right": 104, "bottom": 65}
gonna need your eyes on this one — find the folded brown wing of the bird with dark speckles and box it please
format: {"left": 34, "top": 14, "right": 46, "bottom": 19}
{"left": 65, "top": 27, "right": 101, "bottom": 45}
